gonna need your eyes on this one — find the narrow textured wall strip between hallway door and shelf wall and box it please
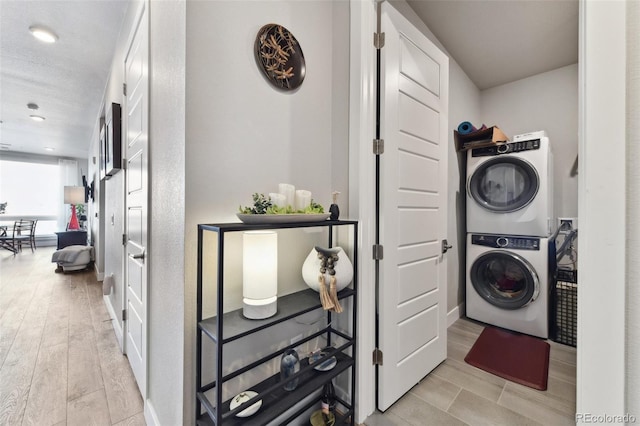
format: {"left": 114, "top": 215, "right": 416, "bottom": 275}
{"left": 150, "top": 0, "right": 188, "bottom": 425}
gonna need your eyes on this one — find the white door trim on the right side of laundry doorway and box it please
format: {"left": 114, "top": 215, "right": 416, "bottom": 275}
{"left": 576, "top": 0, "right": 637, "bottom": 424}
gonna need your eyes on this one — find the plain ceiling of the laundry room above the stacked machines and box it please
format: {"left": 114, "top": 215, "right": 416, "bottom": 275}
{"left": 408, "top": 0, "right": 578, "bottom": 90}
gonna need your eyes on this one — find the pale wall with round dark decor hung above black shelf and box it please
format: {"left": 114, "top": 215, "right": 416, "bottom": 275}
{"left": 184, "top": 1, "right": 349, "bottom": 424}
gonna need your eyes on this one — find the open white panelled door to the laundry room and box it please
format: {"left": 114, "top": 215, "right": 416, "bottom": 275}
{"left": 377, "top": 2, "right": 449, "bottom": 411}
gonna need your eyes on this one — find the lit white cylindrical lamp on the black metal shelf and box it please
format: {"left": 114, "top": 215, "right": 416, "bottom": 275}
{"left": 242, "top": 231, "right": 278, "bottom": 319}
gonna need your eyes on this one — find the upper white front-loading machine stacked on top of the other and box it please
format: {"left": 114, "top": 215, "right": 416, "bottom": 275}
{"left": 467, "top": 131, "right": 555, "bottom": 237}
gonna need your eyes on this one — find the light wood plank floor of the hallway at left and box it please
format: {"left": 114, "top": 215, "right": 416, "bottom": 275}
{"left": 0, "top": 247, "right": 145, "bottom": 426}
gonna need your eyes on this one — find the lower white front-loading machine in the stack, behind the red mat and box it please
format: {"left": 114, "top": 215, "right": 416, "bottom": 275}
{"left": 466, "top": 233, "right": 554, "bottom": 339}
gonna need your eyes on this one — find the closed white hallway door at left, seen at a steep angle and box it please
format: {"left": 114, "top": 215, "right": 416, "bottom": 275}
{"left": 125, "top": 7, "right": 149, "bottom": 397}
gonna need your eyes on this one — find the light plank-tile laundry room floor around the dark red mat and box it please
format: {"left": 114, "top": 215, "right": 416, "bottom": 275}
{"left": 365, "top": 319, "right": 576, "bottom": 426}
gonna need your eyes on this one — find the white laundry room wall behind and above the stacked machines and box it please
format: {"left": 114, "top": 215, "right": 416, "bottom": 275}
{"left": 480, "top": 64, "right": 578, "bottom": 221}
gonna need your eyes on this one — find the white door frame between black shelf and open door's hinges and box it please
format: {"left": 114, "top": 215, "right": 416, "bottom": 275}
{"left": 349, "top": 0, "right": 376, "bottom": 423}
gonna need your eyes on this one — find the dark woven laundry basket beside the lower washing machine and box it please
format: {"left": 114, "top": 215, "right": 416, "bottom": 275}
{"left": 549, "top": 269, "right": 578, "bottom": 347}
